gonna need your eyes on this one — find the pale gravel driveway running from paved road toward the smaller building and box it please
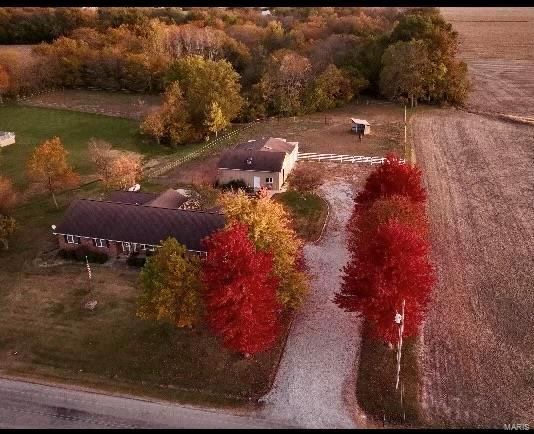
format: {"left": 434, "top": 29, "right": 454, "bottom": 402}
{"left": 261, "top": 181, "right": 360, "bottom": 428}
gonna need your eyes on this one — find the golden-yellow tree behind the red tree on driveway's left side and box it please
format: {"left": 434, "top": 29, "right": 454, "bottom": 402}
{"left": 219, "top": 190, "right": 309, "bottom": 309}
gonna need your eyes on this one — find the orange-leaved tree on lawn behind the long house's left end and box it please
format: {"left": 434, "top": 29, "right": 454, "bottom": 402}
{"left": 27, "top": 137, "right": 80, "bottom": 208}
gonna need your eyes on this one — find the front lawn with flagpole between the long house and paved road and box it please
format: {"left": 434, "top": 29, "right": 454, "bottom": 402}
{"left": 0, "top": 263, "right": 294, "bottom": 402}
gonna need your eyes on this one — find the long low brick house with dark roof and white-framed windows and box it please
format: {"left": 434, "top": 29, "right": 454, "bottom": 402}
{"left": 52, "top": 190, "right": 225, "bottom": 257}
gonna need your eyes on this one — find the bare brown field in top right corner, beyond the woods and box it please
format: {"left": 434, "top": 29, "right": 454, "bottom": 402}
{"left": 441, "top": 8, "right": 534, "bottom": 117}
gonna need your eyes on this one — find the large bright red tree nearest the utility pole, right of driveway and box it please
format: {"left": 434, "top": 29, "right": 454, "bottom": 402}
{"left": 335, "top": 219, "right": 434, "bottom": 343}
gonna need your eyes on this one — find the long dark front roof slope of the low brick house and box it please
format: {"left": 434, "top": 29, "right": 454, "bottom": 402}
{"left": 54, "top": 199, "right": 225, "bottom": 251}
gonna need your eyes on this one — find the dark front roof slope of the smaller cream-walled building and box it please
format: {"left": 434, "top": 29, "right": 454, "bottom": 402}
{"left": 217, "top": 149, "right": 286, "bottom": 172}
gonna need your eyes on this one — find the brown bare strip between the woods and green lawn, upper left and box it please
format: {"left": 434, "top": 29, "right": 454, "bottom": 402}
{"left": 21, "top": 89, "right": 162, "bottom": 119}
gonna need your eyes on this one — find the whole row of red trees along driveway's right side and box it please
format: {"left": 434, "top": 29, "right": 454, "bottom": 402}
{"left": 335, "top": 155, "right": 434, "bottom": 343}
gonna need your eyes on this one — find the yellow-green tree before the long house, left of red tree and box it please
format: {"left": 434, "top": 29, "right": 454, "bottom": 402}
{"left": 137, "top": 238, "right": 202, "bottom": 327}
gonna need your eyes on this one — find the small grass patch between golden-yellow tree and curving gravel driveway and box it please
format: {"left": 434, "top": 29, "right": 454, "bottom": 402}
{"left": 273, "top": 190, "right": 328, "bottom": 241}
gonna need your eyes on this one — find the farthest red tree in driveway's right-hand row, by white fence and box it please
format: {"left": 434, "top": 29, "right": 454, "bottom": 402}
{"left": 356, "top": 153, "right": 426, "bottom": 206}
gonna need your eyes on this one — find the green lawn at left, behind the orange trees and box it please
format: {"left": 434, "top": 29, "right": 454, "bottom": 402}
{"left": 0, "top": 104, "right": 172, "bottom": 188}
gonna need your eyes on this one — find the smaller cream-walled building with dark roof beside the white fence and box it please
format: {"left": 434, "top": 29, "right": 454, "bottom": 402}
{"left": 217, "top": 137, "right": 298, "bottom": 190}
